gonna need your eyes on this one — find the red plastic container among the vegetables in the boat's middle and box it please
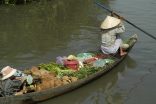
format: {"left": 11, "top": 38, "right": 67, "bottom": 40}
{"left": 64, "top": 60, "right": 79, "bottom": 70}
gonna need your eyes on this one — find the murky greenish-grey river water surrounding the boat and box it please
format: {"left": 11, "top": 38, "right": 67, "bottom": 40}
{"left": 0, "top": 0, "right": 156, "bottom": 104}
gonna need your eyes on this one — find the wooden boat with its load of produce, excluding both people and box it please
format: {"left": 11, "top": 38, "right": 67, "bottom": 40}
{"left": 0, "top": 35, "right": 137, "bottom": 104}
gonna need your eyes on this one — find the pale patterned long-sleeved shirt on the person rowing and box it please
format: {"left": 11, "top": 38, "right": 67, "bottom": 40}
{"left": 101, "top": 22, "right": 125, "bottom": 47}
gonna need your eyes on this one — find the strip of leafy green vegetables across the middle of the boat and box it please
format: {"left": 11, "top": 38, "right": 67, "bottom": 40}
{"left": 39, "top": 62, "right": 103, "bottom": 79}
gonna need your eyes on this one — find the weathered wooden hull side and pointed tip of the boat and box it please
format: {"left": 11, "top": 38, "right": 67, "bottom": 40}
{"left": 0, "top": 35, "right": 137, "bottom": 104}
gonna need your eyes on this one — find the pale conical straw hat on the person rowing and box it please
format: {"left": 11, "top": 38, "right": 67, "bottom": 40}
{"left": 101, "top": 16, "right": 121, "bottom": 29}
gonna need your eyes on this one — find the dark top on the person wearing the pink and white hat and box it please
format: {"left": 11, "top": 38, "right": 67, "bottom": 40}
{"left": 1, "top": 78, "right": 22, "bottom": 96}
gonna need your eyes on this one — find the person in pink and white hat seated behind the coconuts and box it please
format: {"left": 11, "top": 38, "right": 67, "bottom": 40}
{"left": 1, "top": 66, "right": 25, "bottom": 97}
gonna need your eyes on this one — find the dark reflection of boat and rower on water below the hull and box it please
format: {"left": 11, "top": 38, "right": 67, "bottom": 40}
{"left": 38, "top": 55, "right": 137, "bottom": 104}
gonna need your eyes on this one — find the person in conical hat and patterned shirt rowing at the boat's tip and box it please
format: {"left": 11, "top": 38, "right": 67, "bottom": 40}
{"left": 101, "top": 16, "right": 127, "bottom": 56}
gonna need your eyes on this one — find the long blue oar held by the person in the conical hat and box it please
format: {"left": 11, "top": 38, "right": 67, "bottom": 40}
{"left": 94, "top": 0, "right": 156, "bottom": 40}
